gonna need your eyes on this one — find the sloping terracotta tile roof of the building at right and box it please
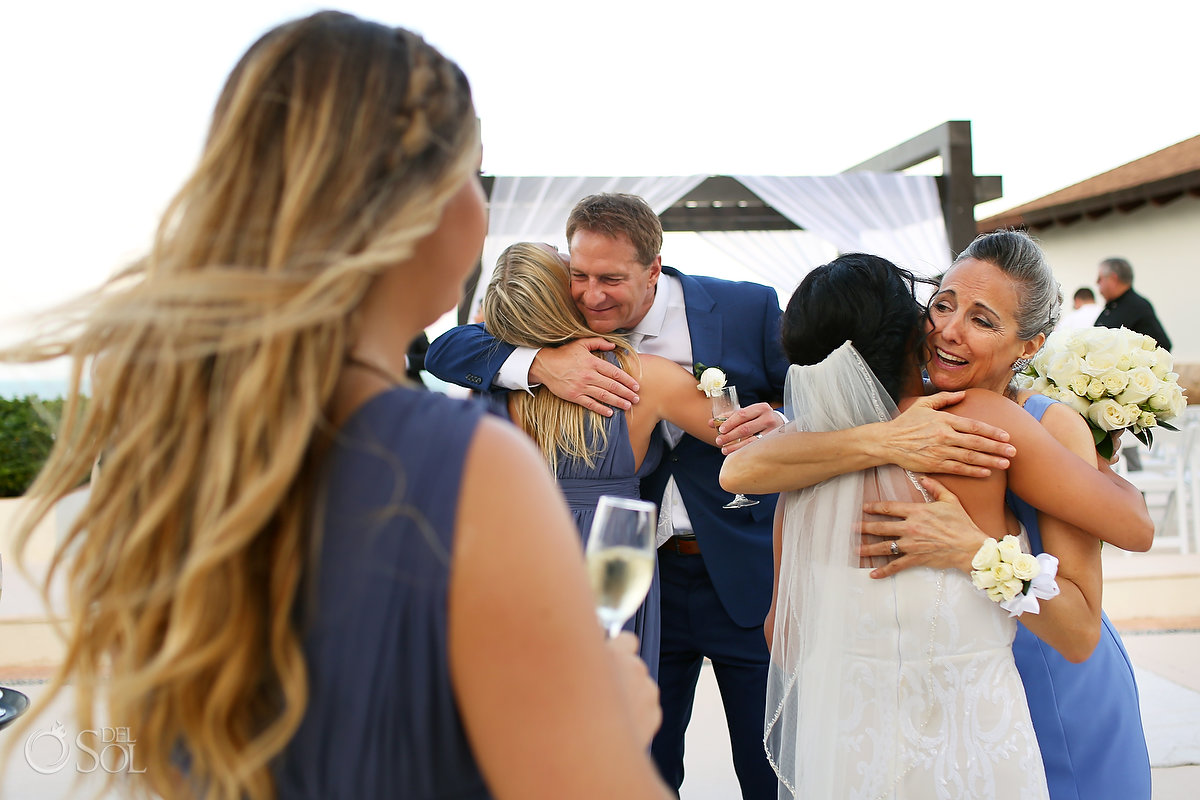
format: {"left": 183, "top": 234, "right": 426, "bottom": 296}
{"left": 977, "top": 136, "right": 1200, "bottom": 233}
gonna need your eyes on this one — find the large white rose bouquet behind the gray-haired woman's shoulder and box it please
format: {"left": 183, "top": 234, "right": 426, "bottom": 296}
{"left": 1016, "top": 327, "right": 1188, "bottom": 458}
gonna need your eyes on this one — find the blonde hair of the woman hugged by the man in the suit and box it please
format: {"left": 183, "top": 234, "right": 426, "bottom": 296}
{"left": 484, "top": 242, "right": 637, "bottom": 470}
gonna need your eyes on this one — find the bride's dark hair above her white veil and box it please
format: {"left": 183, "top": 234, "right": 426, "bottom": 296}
{"left": 782, "top": 253, "right": 936, "bottom": 402}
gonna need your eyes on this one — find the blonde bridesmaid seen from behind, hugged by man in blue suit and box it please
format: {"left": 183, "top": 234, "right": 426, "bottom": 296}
{"left": 484, "top": 242, "right": 716, "bottom": 675}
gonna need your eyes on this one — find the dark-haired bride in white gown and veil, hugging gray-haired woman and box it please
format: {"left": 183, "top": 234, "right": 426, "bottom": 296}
{"left": 748, "top": 254, "right": 1152, "bottom": 800}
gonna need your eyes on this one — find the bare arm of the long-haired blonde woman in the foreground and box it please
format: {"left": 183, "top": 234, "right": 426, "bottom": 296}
{"left": 449, "top": 420, "right": 671, "bottom": 800}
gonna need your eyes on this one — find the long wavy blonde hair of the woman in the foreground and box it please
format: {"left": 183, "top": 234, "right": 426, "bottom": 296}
{"left": 0, "top": 12, "right": 479, "bottom": 800}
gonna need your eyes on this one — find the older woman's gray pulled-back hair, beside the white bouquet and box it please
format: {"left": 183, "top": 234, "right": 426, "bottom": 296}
{"left": 954, "top": 230, "right": 1062, "bottom": 342}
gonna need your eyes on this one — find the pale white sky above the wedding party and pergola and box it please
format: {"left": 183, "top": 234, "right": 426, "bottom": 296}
{"left": 0, "top": 0, "right": 1200, "bottom": 381}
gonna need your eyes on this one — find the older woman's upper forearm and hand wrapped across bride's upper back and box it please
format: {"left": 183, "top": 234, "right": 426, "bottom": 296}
{"left": 721, "top": 392, "right": 1015, "bottom": 494}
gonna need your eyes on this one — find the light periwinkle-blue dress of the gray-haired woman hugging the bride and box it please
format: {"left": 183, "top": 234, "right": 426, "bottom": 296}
{"left": 1008, "top": 395, "right": 1150, "bottom": 800}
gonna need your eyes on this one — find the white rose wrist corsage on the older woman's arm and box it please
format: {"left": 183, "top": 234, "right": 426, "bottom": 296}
{"left": 971, "top": 535, "right": 1058, "bottom": 616}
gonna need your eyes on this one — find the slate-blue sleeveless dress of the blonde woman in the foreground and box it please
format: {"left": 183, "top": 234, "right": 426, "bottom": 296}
{"left": 275, "top": 389, "right": 491, "bottom": 800}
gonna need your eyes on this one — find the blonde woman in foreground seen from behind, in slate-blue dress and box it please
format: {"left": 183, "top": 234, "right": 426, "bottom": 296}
{"left": 4, "top": 12, "right": 668, "bottom": 800}
